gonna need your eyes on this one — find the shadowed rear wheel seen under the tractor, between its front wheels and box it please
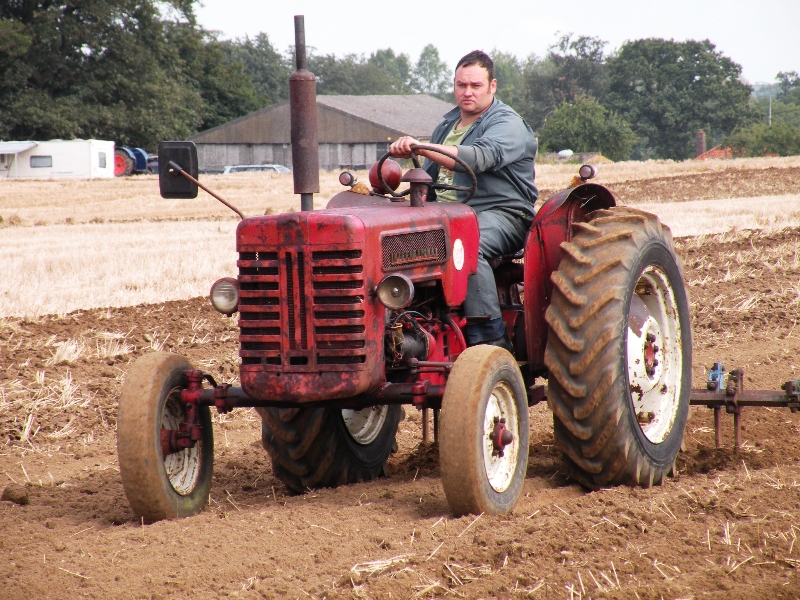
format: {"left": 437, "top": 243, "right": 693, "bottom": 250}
{"left": 256, "top": 405, "right": 403, "bottom": 494}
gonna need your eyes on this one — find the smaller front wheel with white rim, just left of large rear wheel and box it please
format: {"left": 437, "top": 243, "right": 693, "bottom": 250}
{"left": 439, "top": 345, "right": 530, "bottom": 516}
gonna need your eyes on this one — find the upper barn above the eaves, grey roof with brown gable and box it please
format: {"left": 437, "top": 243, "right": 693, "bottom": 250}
{"left": 189, "top": 94, "right": 453, "bottom": 144}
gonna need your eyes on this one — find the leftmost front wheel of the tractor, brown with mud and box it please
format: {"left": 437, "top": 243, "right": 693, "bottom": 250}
{"left": 117, "top": 352, "right": 214, "bottom": 523}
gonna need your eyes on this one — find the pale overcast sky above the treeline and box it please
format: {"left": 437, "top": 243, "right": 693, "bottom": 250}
{"left": 197, "top": 0, "right": 800, "bottom": 83}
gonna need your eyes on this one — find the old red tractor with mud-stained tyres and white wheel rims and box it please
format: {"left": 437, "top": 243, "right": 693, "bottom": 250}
{"left": 117, "top": 19, "right": 691, "bottom": 521}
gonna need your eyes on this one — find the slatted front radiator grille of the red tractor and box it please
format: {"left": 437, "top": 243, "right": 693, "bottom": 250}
{"left": 238, "top": 248, "right": 366, "bottom": 371}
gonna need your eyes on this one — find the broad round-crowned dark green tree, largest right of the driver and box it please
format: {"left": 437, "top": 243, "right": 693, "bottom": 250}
{"left": 602, "top": 38, "right": 758, "bottom": 159}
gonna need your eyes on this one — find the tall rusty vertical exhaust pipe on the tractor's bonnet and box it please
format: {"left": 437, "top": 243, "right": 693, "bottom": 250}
{"left": 289, "top": 15, "right": 319, "bottom": 210}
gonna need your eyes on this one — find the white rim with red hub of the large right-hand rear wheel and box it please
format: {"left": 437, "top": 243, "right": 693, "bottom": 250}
{"left": 627, "top": 265, "right": 683, "bottom": 444}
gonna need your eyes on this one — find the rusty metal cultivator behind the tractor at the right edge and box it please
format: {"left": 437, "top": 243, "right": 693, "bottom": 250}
{"left": 689, "top": 363, "right": 800, "bottom": 449}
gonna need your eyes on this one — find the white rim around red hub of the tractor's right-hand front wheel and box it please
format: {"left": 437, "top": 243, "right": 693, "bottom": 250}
{"left": 483, "top": 381, "right": 519, "bottom": 493}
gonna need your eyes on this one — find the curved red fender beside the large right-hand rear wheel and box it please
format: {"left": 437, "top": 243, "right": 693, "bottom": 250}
{"left": 524, "top": 183, "right": 617, "bottom": 374}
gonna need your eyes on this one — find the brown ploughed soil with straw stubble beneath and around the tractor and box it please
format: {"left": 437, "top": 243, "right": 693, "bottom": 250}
{"left": 0, "top": 230, "right": 800, "bottom": 600}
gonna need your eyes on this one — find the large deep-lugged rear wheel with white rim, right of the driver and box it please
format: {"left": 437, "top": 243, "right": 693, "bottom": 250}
{"left": 545, "top": 207, "right": 692, "bottom": 489}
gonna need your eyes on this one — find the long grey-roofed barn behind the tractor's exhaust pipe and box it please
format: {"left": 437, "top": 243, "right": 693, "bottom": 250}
{"left": 189, "top": 94, "right": 453, "bottom": 172}
